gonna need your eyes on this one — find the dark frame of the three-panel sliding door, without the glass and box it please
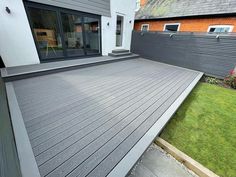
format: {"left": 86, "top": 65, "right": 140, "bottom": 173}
{"left": 24, "top": 1, "right": 102, "bottom": 62}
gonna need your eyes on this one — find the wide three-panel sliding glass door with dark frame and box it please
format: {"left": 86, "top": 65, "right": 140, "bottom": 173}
{"left": 25, "top": 2, "right": 101, "bottom": 60}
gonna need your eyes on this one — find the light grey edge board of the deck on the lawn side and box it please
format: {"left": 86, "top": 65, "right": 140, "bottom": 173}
{"left": 107, "top": 72, "right": 203, "bottom": 177}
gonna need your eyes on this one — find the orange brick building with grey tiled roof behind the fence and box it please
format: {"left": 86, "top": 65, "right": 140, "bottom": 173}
{"left": 134, "top": 0, "right": 236, "bottom": 32}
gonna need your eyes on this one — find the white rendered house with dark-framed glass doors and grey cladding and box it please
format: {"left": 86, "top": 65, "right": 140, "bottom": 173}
{"left": 0, "top": 0, "right": 136, "bottom": 67}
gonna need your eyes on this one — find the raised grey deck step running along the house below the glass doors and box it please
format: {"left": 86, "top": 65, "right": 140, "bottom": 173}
{"left": 1, "top": 54, "right": 138, "bottom": 81}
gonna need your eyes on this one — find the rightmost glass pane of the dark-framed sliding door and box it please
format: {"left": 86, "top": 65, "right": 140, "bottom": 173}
{"left": 84, "top": 17, "right": 100, "bottom": 55}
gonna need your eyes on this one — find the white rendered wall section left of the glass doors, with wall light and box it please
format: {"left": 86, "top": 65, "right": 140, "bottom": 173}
{"left": 0, "top": 0, "right": 39, "bottom": 67}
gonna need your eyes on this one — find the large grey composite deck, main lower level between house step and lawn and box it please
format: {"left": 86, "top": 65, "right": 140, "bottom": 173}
{"left": 4, "top": 58, "right": 202, "bottom": 177}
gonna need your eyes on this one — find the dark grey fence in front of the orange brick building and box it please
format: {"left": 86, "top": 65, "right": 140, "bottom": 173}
{"left": 131, "top": 31, "right": 236, "bottom": 78}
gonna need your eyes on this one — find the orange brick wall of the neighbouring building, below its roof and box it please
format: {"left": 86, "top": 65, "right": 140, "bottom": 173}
{"left": 134, "top": 17, "right": 236, "bottom": 32}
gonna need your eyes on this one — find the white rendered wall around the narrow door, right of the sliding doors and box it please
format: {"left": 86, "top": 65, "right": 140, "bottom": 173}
{"left": 102, "top": 0, "right": 136, "bottom": 55}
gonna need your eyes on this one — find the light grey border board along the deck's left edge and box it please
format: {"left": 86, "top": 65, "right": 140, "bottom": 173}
{"left": 6, "top": 82, "right": 40, "bottom": 177}
